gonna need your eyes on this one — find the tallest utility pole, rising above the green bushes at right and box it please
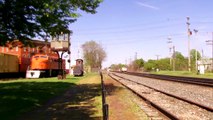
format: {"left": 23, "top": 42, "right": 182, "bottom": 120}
{"left": 186, "top": 17, "right": 192, "bottom": 71}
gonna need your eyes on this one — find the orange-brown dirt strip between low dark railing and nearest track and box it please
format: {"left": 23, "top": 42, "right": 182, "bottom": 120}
{"left": 104, "top": 76, "right": 148, "bottom": 120}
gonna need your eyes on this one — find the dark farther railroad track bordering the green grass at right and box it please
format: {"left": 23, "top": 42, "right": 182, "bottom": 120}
{"left": 115, "top": 71, "right": 213, "bottom": 87}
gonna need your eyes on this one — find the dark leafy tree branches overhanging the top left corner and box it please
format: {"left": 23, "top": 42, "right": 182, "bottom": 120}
{"left": 0, "top": 0, "right": 102, "bottom": 44}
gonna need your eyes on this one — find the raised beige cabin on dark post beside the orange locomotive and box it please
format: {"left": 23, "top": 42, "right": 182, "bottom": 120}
{"left": 51, "top": 32, "right": 71, "bottom": 79}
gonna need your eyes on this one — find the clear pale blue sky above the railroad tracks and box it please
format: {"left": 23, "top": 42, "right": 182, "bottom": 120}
{"left": 70, "top": 0, "right": 213, "bottom": 67}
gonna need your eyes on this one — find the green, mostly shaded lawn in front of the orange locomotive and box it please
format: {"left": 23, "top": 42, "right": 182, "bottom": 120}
{"left": 0, "top": 74, "right": 101, "bottom": 120}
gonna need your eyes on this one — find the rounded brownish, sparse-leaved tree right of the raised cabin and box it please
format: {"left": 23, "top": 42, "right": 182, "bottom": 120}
{"left": 82, "top": 41, "right": 106, "bottom": 68}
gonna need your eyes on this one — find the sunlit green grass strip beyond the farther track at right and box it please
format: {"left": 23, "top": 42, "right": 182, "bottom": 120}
{"left": 152, "top": 71, "right": 213, "bottom": 79}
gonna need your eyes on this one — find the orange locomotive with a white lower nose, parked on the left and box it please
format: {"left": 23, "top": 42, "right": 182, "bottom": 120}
{"left": 26, "top": 54, "right": 65, "bottom": 78}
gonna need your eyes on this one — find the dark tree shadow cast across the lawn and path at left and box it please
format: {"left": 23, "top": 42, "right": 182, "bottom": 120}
{"left": 0, "top": 82, "right": 101, "bottom": 120}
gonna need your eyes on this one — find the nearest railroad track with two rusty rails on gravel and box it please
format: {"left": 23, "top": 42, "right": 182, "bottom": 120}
{"left": 110, "top": 73, "right": 213, "bottom": 119}
